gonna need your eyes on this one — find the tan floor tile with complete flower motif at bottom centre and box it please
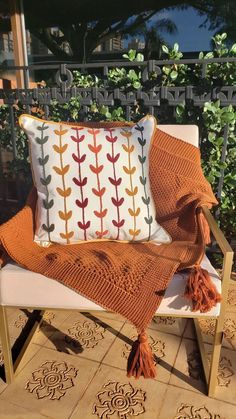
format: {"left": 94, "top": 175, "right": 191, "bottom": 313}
{"left": 70, "top": 365, "right": 167, "bottom": 419}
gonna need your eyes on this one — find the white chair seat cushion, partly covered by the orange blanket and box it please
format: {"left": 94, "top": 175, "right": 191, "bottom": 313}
{"left": 0, "top": 256, "right": 221, "bottom": 317}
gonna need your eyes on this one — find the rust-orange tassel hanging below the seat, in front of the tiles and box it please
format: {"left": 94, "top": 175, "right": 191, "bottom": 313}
{"left": 127, "top": 331, "right": 156, "bottom": 378}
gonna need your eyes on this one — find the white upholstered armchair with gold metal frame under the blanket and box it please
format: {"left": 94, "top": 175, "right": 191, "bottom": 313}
{"left": 0, "top": 125, "right": 233, "bottom": 396}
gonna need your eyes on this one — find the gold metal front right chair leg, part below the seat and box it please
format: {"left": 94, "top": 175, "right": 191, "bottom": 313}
{"left": 208, "top": 318, "right": 224, "bottom": 397}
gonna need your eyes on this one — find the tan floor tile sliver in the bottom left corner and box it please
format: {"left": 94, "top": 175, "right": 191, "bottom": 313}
{"left": 0, "top": 401, "right": 48, "bottom": 419}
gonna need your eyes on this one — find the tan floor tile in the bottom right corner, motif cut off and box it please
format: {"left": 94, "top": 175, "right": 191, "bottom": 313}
{"left": 157, "top": 386, "right": 236, "bottom": 419}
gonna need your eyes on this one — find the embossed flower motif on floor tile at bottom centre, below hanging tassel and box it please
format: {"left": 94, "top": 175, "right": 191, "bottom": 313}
{"left": 93, "top": 381, "right": 146, "bottom": 419}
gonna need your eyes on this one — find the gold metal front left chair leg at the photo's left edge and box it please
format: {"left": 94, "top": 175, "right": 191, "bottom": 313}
{"left": 0, "top": 306, "right": 14, "bottom": 384}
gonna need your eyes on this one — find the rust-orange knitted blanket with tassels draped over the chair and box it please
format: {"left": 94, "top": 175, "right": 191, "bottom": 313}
{"left": 0, "top": 123, "right": 219, "bottom": 377}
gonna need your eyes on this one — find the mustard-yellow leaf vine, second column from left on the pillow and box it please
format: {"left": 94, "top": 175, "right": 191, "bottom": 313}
{"left": 53, "top": 125, "right": 74, "bottom": 244}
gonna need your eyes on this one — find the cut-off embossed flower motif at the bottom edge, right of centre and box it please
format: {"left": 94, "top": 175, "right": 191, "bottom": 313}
{"left": 173, "top": 403, "right": 223, "bottom": 419}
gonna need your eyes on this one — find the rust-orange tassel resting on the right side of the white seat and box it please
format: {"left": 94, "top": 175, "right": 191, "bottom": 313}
{"left": 184, "top": 265, "right": 221, "bottom": 313}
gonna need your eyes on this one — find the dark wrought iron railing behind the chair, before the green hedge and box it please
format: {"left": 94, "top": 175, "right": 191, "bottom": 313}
{"left": 0, "top": 57, "right": 236, "bottom": 223}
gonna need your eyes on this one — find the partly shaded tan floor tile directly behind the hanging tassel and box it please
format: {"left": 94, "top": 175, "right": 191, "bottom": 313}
{"left": 102, "top": 323, "right": 180, "bottom": 383}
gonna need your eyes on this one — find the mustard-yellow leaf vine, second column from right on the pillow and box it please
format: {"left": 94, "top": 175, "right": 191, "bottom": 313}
{"left": 121, "top": 131, "right": 141, "bottom": 240}
